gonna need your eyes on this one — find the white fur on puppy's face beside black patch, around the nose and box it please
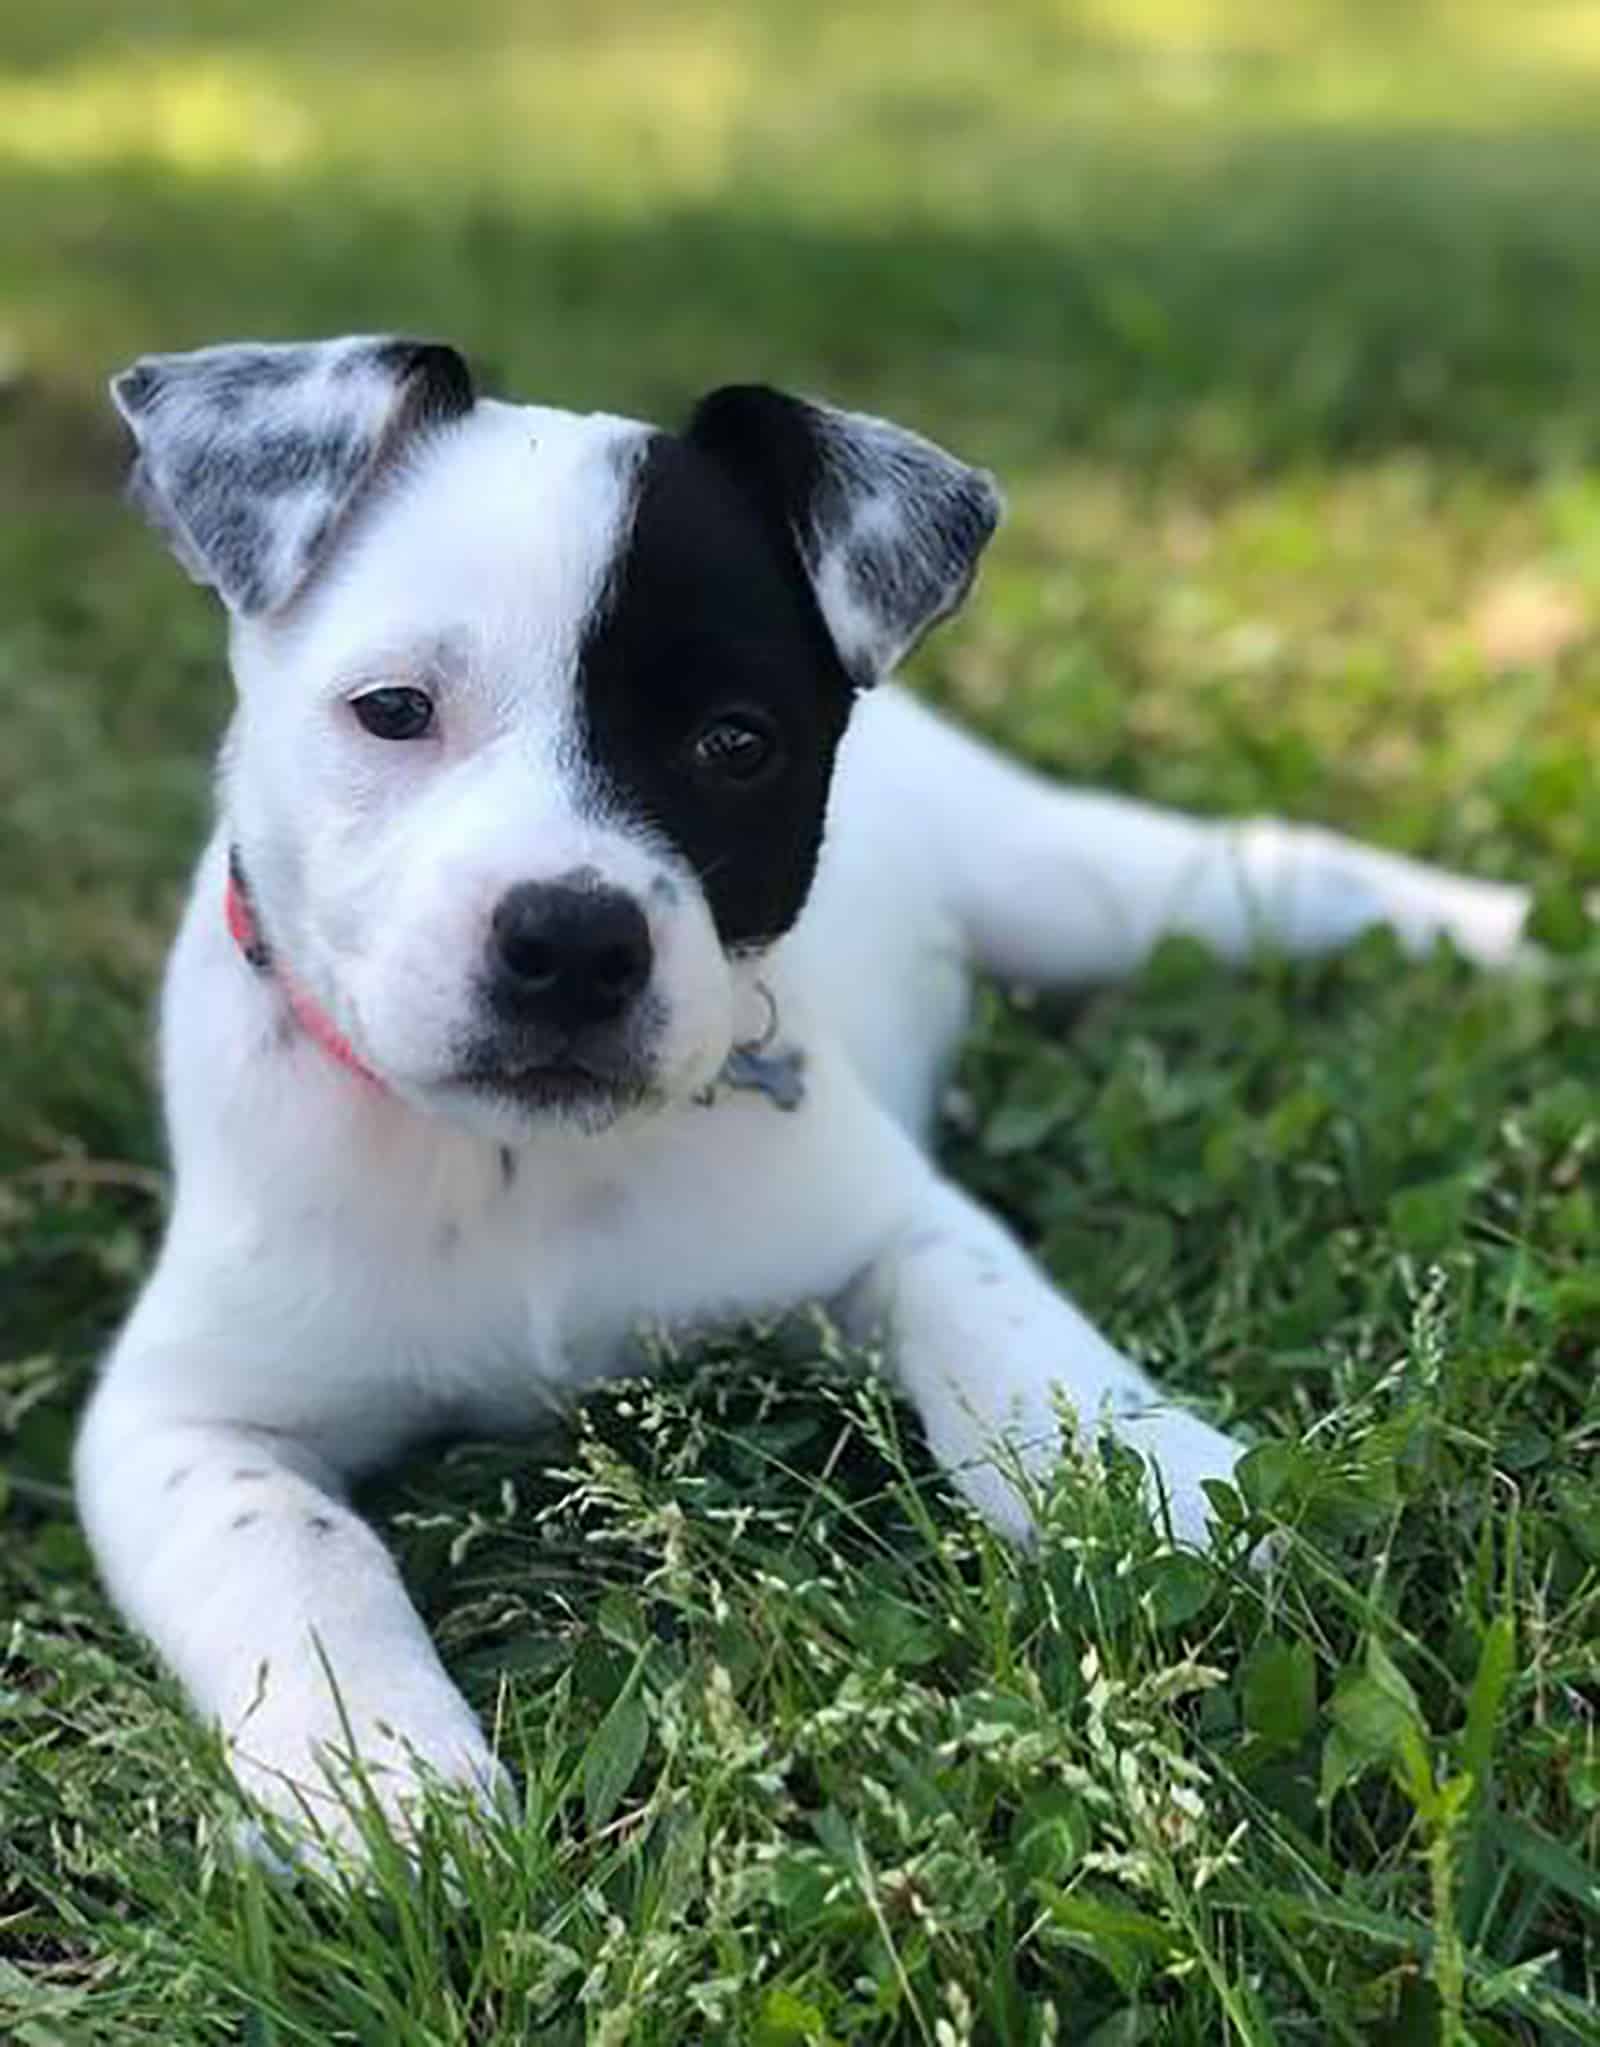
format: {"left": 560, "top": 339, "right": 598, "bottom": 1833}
{"left": 227, "top": 403, "right": 735, "bottom": 1129}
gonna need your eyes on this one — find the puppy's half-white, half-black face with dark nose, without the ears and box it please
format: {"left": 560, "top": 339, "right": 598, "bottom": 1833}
{"left": 229, "top": 405, "right": 849, "bottom": 1122}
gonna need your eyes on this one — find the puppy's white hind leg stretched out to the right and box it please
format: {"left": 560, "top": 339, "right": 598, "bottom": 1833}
{"left": 896, "top": 702, "right": 1528, "bottom": 987}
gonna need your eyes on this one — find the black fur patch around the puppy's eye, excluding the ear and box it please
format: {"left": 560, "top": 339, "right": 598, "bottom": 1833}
{"left": 577, "top": 434, "right": 853, "bottom": 948}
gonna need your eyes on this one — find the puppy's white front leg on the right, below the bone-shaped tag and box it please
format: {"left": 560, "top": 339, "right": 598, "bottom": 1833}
{"left": 845, "top": 1169, "right": 1240, "bottom": 1545}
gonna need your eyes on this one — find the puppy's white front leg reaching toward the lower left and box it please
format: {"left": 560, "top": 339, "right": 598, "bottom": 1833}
{"left": 76, "top": 1333, "right": 499, "bottom": 1846}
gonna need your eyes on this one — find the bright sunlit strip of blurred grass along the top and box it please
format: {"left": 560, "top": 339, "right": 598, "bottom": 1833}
{"left": 0, "top": 0, "right": 1600, "bottom": 215}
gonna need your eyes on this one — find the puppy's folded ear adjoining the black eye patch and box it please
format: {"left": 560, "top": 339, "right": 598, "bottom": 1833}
{"left": 687, "top": 385, "right": 1001, "bottom": 688}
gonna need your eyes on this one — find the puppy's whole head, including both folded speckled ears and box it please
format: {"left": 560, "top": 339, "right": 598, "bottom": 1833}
{"left": 113, "top": 338, "right": 998, "bottom": 1140}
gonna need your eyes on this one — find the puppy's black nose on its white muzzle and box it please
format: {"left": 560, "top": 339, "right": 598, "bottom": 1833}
{"left": 489, "top": 882, "right": 651, "bottom": 1030}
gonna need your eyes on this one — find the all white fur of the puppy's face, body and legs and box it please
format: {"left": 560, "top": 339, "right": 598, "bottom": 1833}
{"left": 78, "top": 386, "right": 1524, "bottom": 1836}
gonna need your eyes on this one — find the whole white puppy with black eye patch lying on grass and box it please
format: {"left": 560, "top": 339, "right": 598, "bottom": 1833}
{"left": 78, "top": 338, "right": 1524, "bottom": 1832}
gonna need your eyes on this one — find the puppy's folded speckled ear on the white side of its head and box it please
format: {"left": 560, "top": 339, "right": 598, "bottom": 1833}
{"left": 110, "top": 336, "right": 473, "bottom": 618}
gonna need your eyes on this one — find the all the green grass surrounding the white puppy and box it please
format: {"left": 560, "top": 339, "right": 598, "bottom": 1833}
{"left": 0, "top": 0, "right": 1600, "bottom": 2047}
